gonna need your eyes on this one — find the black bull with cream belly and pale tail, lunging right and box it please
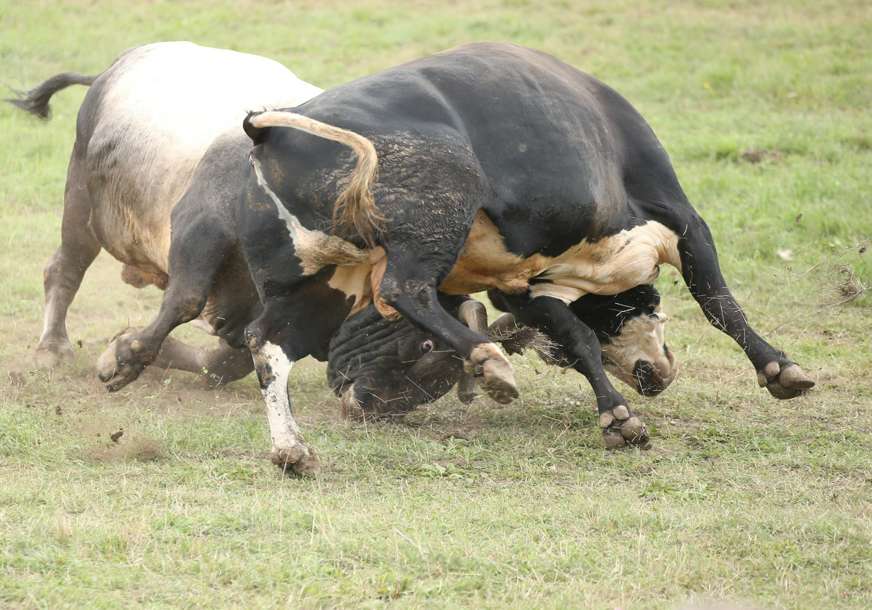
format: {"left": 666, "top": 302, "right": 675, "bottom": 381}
{"left": 238, "top": 44, "right": 813, "bottom": 466}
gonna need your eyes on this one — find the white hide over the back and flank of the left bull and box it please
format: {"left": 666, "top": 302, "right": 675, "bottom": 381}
{"left": 87, "top": 42, "right": 321, "bottom": 272}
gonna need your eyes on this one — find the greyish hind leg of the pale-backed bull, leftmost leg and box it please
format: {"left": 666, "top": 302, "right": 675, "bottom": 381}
{"left": 35, "top": 151, "right": 100, "bottom": 368}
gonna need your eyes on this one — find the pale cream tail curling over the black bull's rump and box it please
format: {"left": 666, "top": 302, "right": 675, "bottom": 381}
{"left": 243, "top": 110, "right": 385, "bottom": 247}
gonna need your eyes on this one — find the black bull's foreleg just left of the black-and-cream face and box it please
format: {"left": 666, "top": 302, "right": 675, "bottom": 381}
{"left": 488, "top": 290, "right": 649, "bottom": 449}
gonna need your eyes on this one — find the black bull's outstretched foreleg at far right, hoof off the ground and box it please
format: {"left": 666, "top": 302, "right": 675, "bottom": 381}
{"left": 678, "top": 213, "right": 814, "bottom": 399}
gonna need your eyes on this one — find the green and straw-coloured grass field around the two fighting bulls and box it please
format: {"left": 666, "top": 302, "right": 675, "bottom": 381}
{"left": 0, "top": 0, "right": 872, "bottom": 610}
